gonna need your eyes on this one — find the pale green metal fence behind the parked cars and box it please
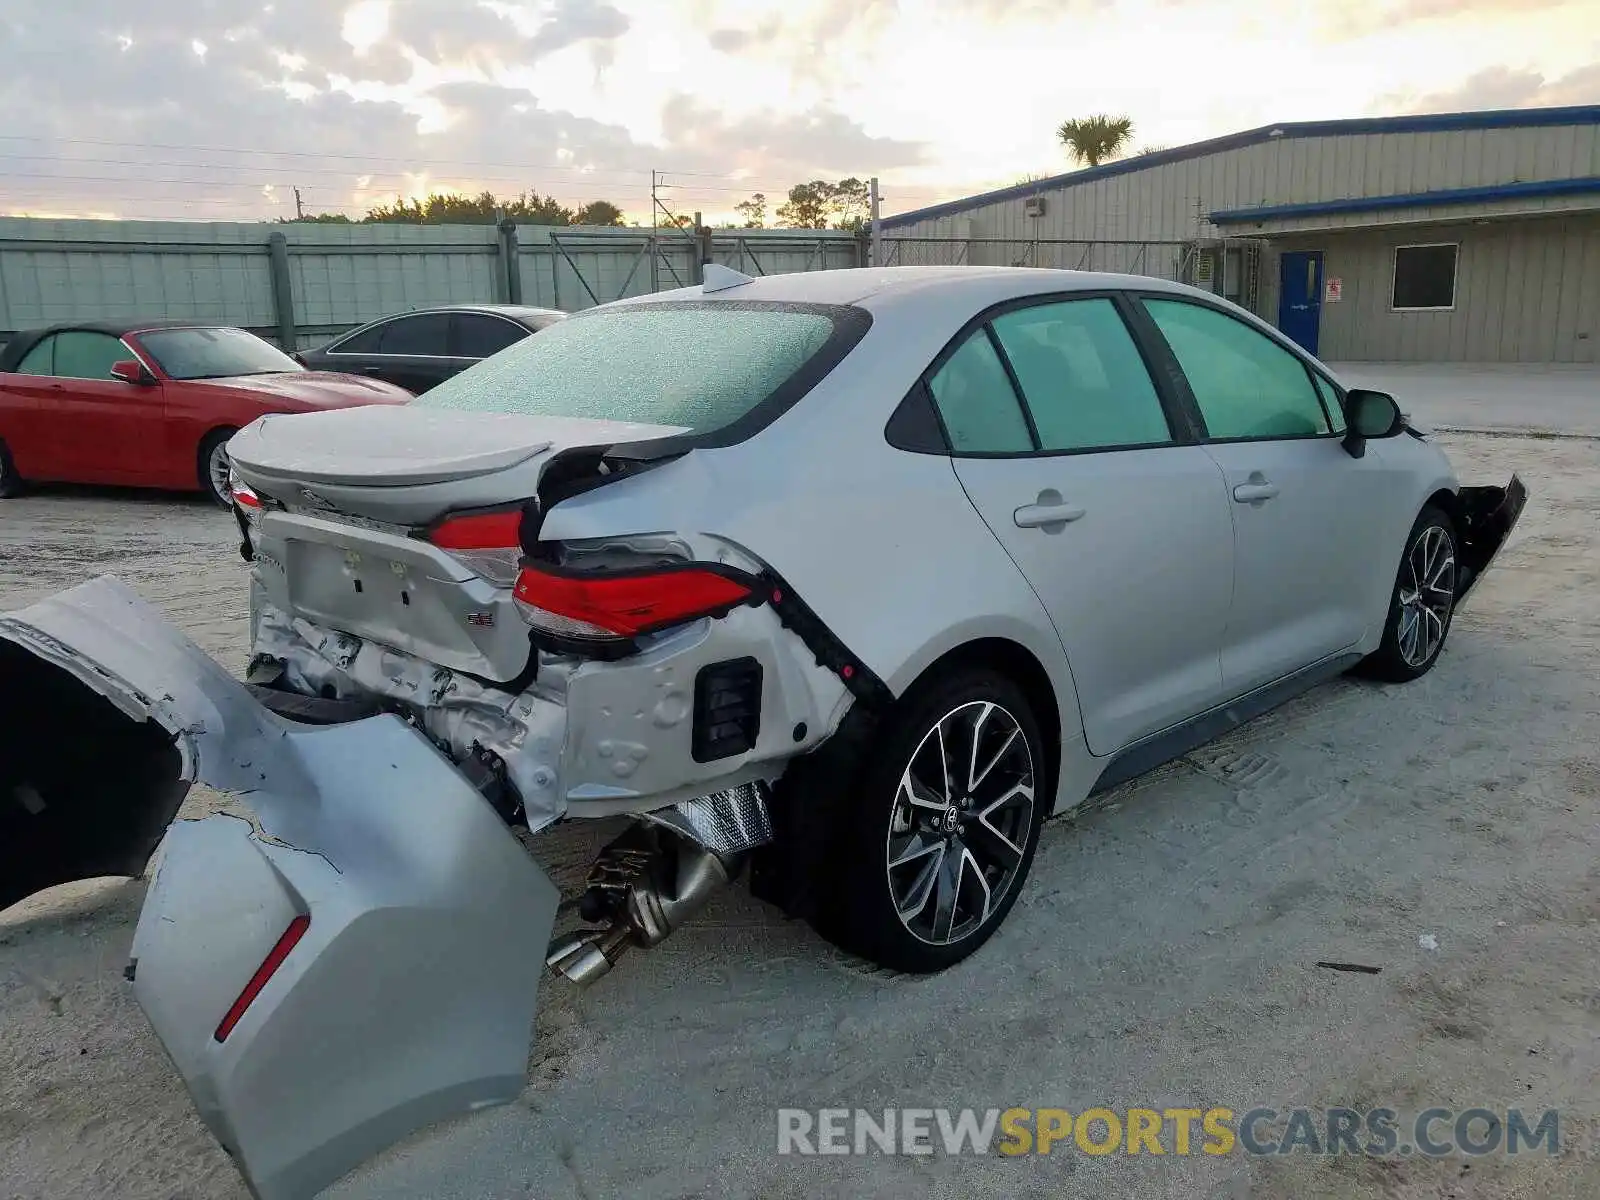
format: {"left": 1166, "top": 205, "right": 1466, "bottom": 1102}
{"left": 0, "top": 218, "right": 866, "bottom": 349}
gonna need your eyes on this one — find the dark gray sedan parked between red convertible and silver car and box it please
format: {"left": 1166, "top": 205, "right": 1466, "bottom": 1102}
{"left": 294, "top": 304, "right": 566, "bottom": 395}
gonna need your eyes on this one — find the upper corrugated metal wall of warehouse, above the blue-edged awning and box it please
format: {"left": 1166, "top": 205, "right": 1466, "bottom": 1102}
{"left": 886, "top": 125, "right": 1600, "bottom": 242}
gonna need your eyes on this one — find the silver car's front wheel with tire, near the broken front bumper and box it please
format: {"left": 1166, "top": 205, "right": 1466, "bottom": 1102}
{"left": 1358, "top": 504, "right": 1459, "bottom": 683}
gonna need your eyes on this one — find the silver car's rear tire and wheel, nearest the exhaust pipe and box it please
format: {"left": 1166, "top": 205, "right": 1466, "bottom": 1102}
{"left": 813, "top": 667, "right": 1054, "bottom": 974}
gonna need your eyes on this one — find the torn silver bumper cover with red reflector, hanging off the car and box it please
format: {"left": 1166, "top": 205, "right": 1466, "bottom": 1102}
{"left": 0, "top": 579, "right": 558, "bottom": 1200}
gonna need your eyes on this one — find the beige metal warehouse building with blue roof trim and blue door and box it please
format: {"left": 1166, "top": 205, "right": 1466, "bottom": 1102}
{"left": 878, "top": 106, "right": 1600, "bottom": 363}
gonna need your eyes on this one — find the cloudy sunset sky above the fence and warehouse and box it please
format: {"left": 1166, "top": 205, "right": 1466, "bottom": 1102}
{"left": 0, "top": 0, "right": 1600, "bottom": 222}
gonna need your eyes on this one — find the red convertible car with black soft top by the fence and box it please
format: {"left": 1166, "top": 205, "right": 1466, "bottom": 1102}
{"left": 0, "top": 322, "right": 411, "bottom": 504}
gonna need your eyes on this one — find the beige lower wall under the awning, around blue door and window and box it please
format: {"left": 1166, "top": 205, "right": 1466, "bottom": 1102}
{"left": 1259, "top": 216, "right": 1600, "bottom": 363}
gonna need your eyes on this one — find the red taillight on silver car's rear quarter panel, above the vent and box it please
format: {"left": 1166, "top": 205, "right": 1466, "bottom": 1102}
{"left": 515, "top": 565, "right": 755, "bottom": 640}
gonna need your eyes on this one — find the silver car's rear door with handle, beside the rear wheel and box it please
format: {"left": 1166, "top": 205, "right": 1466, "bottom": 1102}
{"left": 926, "top": 294, "right": 1234, "bottom": 755}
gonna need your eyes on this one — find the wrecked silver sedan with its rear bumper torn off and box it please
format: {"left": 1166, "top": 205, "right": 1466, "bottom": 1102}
{"left": 0, "top": 267, "right": 1526, "bottom": 1200}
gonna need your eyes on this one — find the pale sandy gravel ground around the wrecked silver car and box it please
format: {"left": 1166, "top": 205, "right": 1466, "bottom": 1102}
{"left": 0, "top": 435, "right": 1600, "bottom": 1200}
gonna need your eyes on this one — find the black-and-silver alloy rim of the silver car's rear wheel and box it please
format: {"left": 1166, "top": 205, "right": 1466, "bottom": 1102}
{"left": 886, "top": 701, "right": 1035, "bottom": 946}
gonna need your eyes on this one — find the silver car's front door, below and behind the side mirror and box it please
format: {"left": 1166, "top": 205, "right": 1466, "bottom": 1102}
{"left": 1142, "top": 296, "right": 1389, "bottom": 696}
